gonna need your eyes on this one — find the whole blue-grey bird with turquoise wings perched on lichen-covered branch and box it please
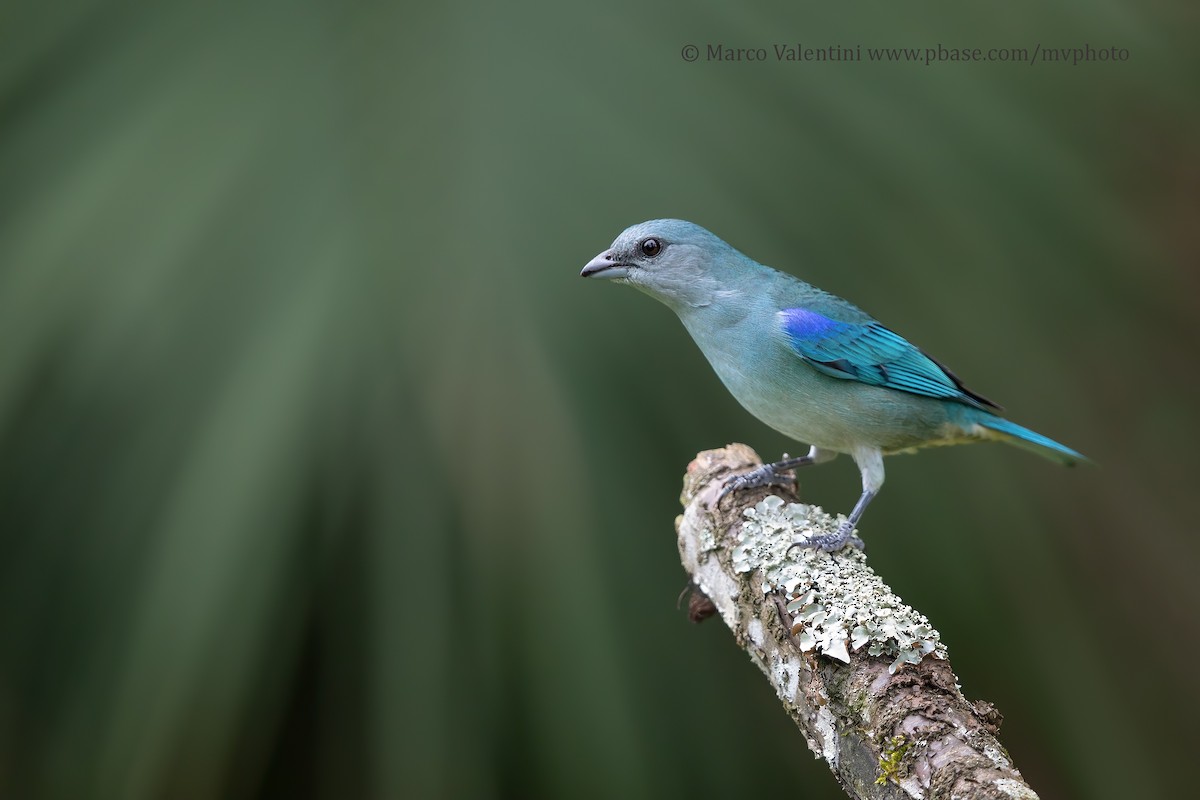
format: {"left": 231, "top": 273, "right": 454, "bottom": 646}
{"left": 580, "top": 219, "right": 1087, "bottom": 552}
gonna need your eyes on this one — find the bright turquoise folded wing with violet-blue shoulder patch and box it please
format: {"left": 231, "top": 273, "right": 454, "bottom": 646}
{"left": 778, "top": 308, "right": 1000, "bottom": 409}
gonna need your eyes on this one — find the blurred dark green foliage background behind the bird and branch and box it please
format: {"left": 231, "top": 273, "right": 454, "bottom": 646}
{"left": 0, "top": 0, "right": 1200, "bottom": 800}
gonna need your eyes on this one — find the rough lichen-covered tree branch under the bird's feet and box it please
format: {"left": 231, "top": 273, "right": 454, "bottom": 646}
{"left": 676, "top": 444, "right": 1037, "bottom": 800}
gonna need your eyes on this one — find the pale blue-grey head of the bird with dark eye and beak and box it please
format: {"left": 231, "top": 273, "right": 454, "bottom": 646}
{"left": 580, "top": 219, "right": 752, "bottom": 309}
